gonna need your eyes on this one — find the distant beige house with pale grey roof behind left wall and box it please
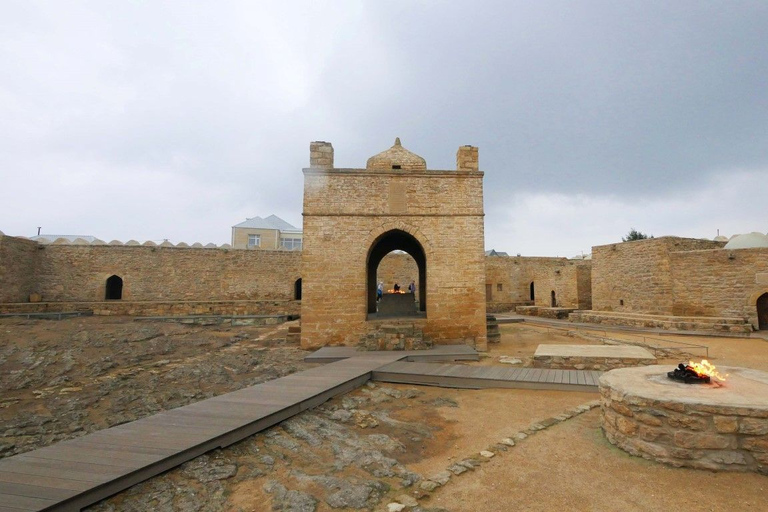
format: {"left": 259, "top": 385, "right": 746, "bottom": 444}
{"left": 232, "top": 215, "right": 303, "bottom": 251}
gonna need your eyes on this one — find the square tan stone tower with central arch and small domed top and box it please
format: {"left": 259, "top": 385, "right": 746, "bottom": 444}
{"left": 301, "top": 139, "right": 486, "bottom": 350}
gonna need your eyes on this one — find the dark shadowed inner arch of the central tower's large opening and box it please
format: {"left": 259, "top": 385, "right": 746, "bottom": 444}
{"left": 365, "top": 229, "right": 427, "bottom": 314}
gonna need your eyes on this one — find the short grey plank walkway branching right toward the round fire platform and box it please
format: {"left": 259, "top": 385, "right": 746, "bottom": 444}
{"left": 372, "top": 361, "right": 602, "bottom": 392}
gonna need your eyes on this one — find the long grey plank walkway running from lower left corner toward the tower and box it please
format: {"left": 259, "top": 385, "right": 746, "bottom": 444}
{"left": 0, "top": 352, "right": 404, "bottom": 512}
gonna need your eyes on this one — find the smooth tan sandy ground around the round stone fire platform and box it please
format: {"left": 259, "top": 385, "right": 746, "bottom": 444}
{"left": 414, "top": 324, "right": 768, "bottom": 512}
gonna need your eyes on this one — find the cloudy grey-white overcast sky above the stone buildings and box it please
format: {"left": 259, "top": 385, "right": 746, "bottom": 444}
{"left": 0, "top": 0, "right": 768, "bottom": 256}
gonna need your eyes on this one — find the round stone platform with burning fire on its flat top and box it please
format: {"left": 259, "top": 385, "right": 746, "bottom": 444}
{"left": 600, "top": 365, "right": 768, "bottom": 474}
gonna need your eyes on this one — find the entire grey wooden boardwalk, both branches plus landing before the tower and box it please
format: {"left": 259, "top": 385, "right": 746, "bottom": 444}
{"left": 0, "top": 345, "right": 599, "bottom": 512}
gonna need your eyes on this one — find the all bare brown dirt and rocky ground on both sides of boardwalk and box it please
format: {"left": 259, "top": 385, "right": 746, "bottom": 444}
{"left": 0, "top": 318, "right": 768, "bottom": 512}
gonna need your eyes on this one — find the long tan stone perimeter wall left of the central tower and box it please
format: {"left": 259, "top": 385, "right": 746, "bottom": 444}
{"left": 0, "top": 236, "right": 301, "bottom": 308}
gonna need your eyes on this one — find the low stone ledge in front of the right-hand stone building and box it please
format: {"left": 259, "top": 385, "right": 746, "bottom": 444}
{"left": 568, "top": 310, "right": 753, "bottom": 336}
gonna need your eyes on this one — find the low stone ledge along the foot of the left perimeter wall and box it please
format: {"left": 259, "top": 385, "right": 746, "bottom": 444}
{"left": 0, "top": 300, "right": 301, "bottom": 316}
